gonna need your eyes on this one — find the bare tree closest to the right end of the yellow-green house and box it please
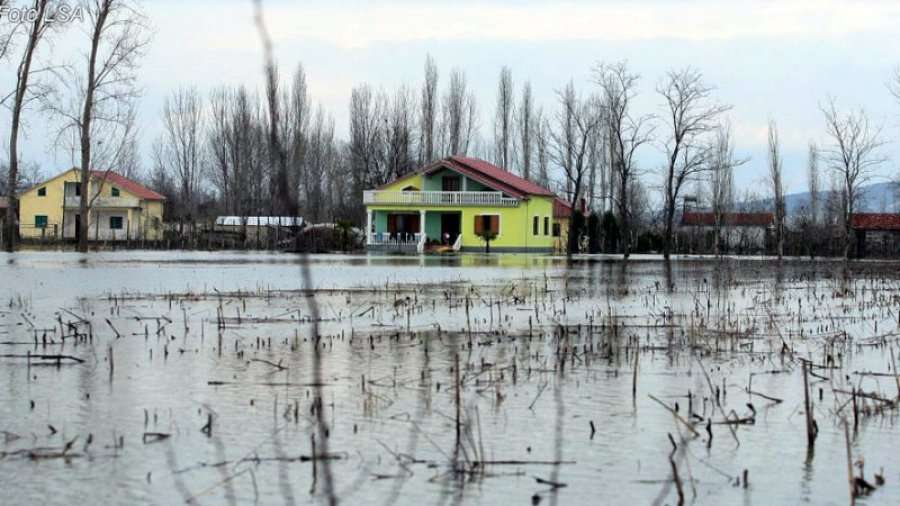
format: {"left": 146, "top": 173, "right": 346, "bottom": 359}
{"left": 551, "top": 81, "right": 603, "bottom": 254}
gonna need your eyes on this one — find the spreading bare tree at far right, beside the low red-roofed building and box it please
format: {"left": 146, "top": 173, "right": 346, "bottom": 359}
{"left": 820, "top": 99, "right": 885, "bottom": 260}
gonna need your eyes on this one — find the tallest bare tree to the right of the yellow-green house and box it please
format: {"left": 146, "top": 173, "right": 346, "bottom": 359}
{"left": 594, "top": 61, "right": 653, "bottom": 258}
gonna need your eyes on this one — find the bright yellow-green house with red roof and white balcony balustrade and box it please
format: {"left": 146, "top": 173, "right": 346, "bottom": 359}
{"left": 363, "top": 156, "right": 560, "bottom": 253}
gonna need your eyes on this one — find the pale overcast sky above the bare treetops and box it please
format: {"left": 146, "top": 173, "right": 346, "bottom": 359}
{"left": 0, "top": 0, "right": 900, "bottom": 191}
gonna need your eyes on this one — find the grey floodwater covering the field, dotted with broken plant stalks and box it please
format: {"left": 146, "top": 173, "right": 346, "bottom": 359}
{"left": 0, "top": 252, "right": 900, "bottom": 505}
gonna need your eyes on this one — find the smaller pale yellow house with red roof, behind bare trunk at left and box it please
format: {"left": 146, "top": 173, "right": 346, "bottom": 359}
{"left": 19, "top": 168, "right": 166, "bottom": 241}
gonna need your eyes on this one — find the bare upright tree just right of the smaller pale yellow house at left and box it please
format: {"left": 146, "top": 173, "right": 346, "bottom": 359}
{"left": 154, "top": 88, "right": 206, "bottom": 220}
